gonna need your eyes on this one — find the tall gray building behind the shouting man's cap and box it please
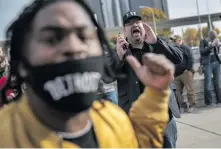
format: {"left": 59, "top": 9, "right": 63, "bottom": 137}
{"left": 85, "top": 0, "right": 169, "bottom": 28}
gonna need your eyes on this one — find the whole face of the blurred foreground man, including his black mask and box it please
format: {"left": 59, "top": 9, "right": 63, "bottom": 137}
{"left": 20, "top": 0, "right": 104, "bottom": 114}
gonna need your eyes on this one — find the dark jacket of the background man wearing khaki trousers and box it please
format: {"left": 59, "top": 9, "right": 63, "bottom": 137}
{"left": 175, "top": 44, "right": 194, "bottom": 76}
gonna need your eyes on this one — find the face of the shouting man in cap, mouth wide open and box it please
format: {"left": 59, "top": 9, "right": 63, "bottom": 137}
{"left": 124, "top": 18, "right": 145, "bottom": 43}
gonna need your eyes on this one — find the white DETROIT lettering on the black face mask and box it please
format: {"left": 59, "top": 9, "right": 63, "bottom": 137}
{"left": 44, "top": 72, "right": 101, "bottom": 101}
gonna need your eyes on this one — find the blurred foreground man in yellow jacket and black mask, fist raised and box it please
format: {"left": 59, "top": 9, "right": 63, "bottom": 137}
{"left": 0, "top": 0, "right": 174, "bottom": 148}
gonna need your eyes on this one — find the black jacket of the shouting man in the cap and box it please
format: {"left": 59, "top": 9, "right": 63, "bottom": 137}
{"left": 109, "top": 38, "right": 182, "bottom": 113}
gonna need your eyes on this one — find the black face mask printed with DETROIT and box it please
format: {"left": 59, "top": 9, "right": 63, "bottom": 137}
{"left": 24, "top": 56, "right": 104, "bottom": 113}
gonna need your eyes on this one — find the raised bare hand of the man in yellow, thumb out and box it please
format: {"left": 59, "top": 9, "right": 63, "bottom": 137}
{"left": 127, "top": 53, "right": 174, "bottom": 90}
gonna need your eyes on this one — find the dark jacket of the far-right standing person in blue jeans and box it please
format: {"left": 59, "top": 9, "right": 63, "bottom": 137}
{"left": 200, "top": 39, "right": 221, "bottom": 65}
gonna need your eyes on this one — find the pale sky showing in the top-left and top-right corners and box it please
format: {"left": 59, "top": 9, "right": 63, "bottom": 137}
{"left": 0, "top": 0, "right": 221, "bottom": 40}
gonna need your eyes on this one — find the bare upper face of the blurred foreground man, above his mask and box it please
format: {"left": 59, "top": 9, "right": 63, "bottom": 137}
{"left": 25, "top": 1, "right": 102, "bottom": 66}
